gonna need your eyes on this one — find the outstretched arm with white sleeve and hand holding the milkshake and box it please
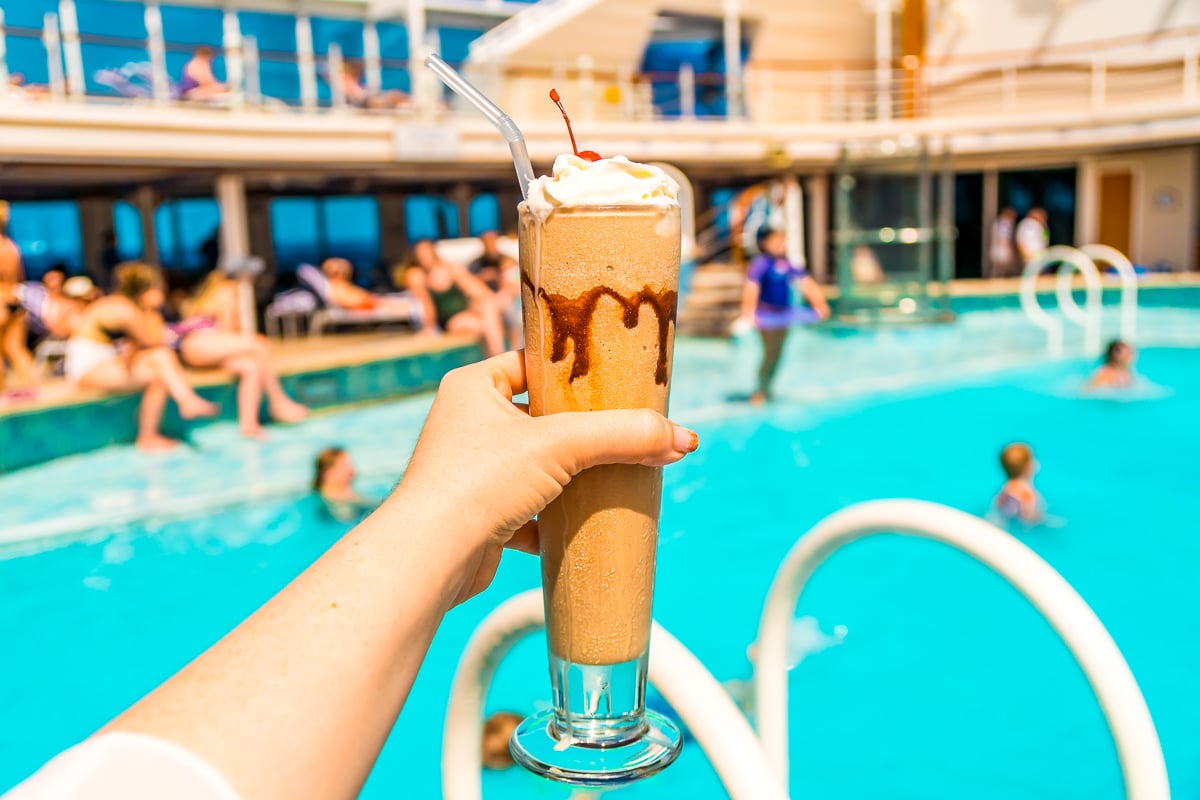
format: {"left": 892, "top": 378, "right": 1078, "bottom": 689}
{"left": 10, "top": 353, "right": 698, "bottom": 800}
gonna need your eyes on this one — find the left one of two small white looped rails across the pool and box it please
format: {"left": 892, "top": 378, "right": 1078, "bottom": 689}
{"left": 1020, "top": 245, "right": 1100, "bottom": 357}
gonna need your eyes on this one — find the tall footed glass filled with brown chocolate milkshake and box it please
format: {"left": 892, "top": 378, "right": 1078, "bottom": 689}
{"left": 511, "top": 204, "right": 680, "bottom": 786}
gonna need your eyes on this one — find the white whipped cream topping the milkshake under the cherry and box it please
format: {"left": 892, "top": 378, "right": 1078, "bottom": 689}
{"left": 526, "top": 154, "right": 679, "bottom": 217}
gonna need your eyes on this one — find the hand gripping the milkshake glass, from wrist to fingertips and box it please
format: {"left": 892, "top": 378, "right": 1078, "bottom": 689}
{"left": 396, "top": 351, "right": 698, "bottom": 602}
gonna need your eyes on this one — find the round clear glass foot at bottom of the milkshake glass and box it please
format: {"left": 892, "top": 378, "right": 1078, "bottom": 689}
{"left": 509, "top": 711, "right": 683, "bottom": 787}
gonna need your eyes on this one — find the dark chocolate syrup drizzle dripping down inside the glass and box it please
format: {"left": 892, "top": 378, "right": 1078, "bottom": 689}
{"left": 521, "top": 272, "right": 679, "bottom": 386}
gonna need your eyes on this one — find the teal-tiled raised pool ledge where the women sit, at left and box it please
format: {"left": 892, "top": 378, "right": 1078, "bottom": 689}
{"left": 0, "top": 333, "right": 481, "bottom": 474}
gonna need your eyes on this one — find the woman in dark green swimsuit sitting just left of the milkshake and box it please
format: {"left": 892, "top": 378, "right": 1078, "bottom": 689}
{"left": 404, "top": 239, "right": 504, "bottom": 356}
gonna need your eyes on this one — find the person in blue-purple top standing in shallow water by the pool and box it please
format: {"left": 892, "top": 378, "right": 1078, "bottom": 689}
{"left": 740, "top": 228, "right": 829, "bottom": 405}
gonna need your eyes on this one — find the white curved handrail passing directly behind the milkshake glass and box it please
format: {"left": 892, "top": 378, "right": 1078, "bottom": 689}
{"left": 442, "top": 589, "right": 787, "bottom": 800}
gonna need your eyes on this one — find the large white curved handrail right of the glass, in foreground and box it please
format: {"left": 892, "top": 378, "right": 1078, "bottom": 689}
{"left": 755, "top": 500, "right": 1170, "bottom": 800}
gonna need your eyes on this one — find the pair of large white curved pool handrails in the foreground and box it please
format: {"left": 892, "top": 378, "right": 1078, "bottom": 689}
{"left": 442, "top": 500, "right": 1170, "bottom": 800}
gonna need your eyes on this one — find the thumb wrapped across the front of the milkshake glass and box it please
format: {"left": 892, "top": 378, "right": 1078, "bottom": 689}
{"left": 535, "top": 409, "right": 700, "bottom": 475}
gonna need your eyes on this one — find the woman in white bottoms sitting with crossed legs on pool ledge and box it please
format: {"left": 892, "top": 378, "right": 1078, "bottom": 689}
{"left": 65, "top": 264, "right": 218, "bottom": 451}
